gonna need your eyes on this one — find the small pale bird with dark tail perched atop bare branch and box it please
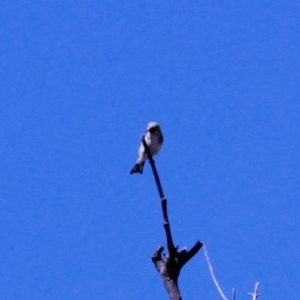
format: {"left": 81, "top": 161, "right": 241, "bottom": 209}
{"left": 130, "top": 122, "right": 164, "bottom": 174}
